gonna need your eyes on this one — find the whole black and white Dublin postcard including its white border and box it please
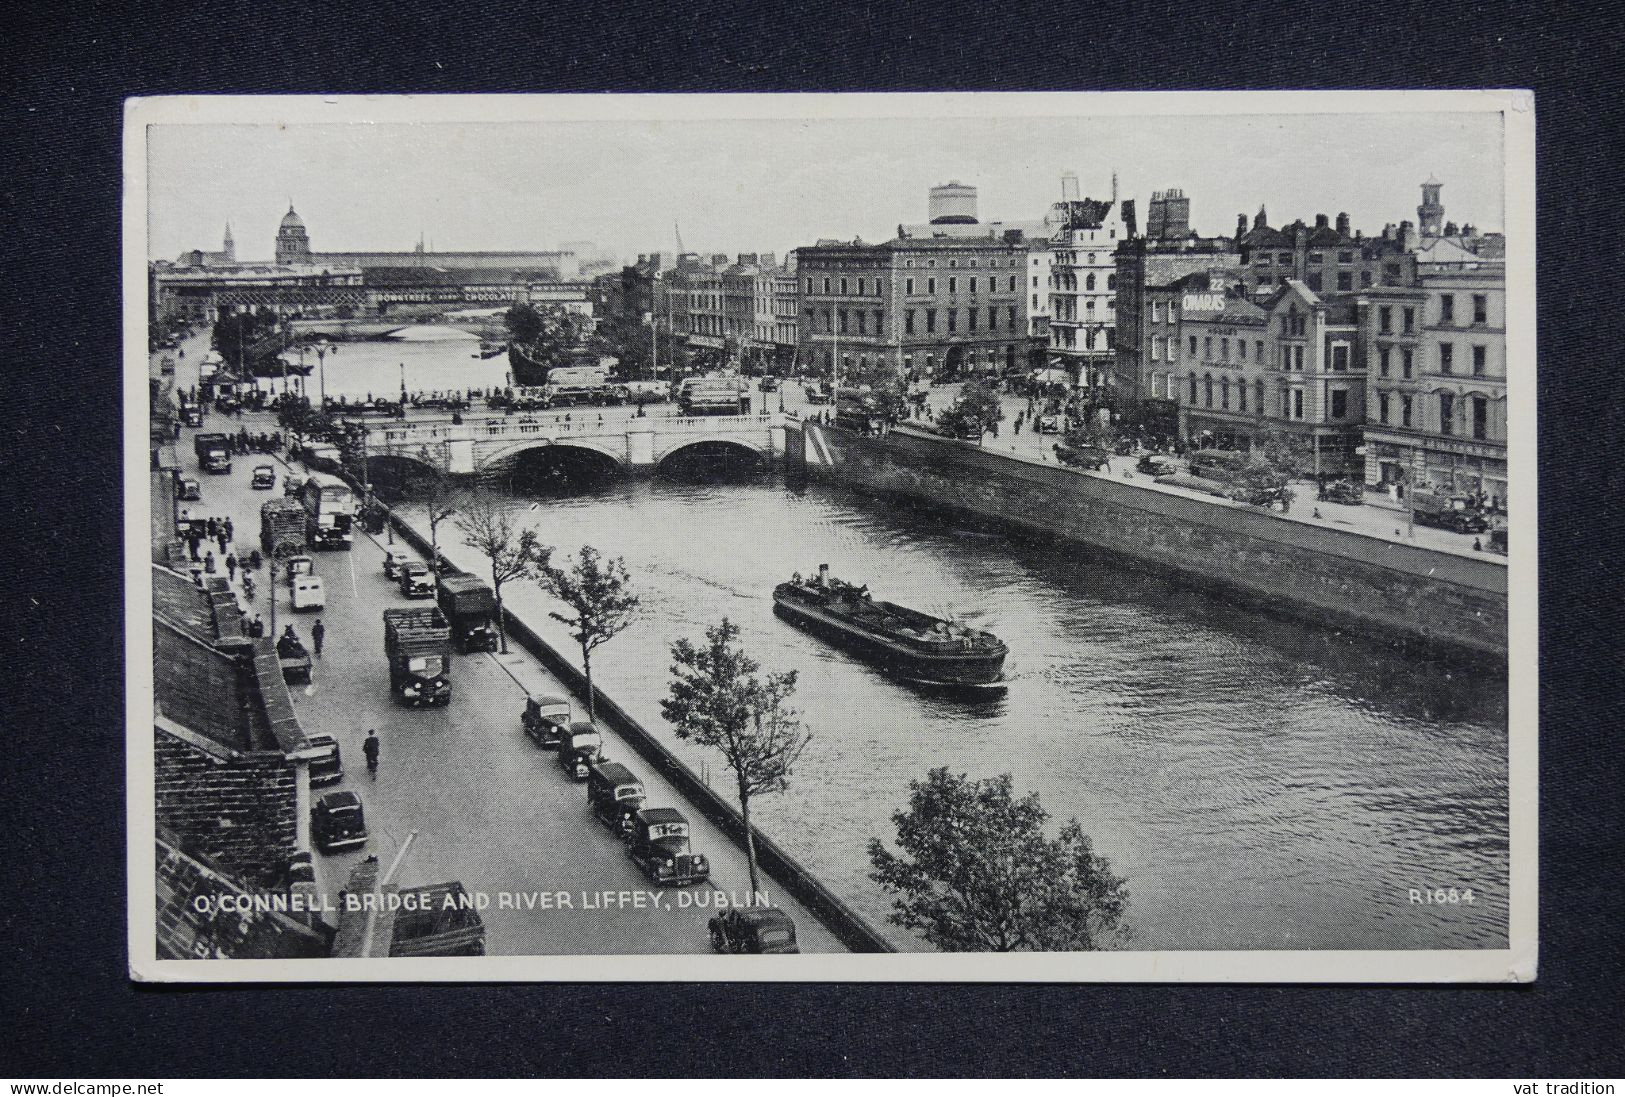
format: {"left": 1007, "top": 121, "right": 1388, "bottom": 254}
{"left": 124, "top": 91, "right": 1537, "bottom": 983}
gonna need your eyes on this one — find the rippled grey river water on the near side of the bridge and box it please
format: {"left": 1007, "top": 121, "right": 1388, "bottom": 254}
{"left": 408, "top": 476, "right": 1508, "bottom": 949}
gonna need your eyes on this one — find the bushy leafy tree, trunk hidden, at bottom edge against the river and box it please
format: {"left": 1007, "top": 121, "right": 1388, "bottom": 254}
{"left": 869, "top": 767, "right": 1128, "bottom": 952}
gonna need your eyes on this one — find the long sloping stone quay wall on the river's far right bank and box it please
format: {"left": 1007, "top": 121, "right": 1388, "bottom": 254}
{"left": 799, "top": 423, "right": 1508, "bottom": 666}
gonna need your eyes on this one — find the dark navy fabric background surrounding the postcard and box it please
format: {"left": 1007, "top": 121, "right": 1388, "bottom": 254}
{"left": 0, "top": 0, "right": 1625, "bottom": 1077}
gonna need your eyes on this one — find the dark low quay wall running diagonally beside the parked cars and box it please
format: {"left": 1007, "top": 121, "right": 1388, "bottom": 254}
{"left": 381, "top": 514, "right": 895, "bottom": 952}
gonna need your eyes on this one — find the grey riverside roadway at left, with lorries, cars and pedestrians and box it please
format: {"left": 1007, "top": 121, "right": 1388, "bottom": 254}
{"left": 161, "top": 341, "right": 845, "bottom": 956}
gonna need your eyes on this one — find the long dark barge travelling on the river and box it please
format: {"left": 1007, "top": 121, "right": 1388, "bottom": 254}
{"left": 774, "top": 564, "right": 1009, "bottom": 687}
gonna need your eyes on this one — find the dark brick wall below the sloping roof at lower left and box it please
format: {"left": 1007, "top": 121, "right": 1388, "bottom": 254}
{"left": 153, "top": 726, "right": 297, "bottom": 886}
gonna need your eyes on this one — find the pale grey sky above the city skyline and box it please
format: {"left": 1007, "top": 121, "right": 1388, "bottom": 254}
{"left": 148, "top": 112, "right": 1505, "bottom": 260}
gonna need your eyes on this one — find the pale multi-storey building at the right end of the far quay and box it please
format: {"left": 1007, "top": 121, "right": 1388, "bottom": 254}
{"left": 1363, "top": 242, "right": 1506, "bottom": 507}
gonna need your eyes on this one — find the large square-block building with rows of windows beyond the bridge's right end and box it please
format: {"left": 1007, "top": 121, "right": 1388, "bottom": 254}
{"left": 796, "top": 226, "right": 1029, "bottom": 380}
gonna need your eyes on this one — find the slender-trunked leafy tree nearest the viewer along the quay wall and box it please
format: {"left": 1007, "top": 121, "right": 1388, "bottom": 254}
{"left": 660, "top": 618, "right": 813, "bottom": 895}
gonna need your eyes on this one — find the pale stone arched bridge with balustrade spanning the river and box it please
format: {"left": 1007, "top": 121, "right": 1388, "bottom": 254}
{"left": 361, "top": 408, "right": 785, "bottom": 475}
